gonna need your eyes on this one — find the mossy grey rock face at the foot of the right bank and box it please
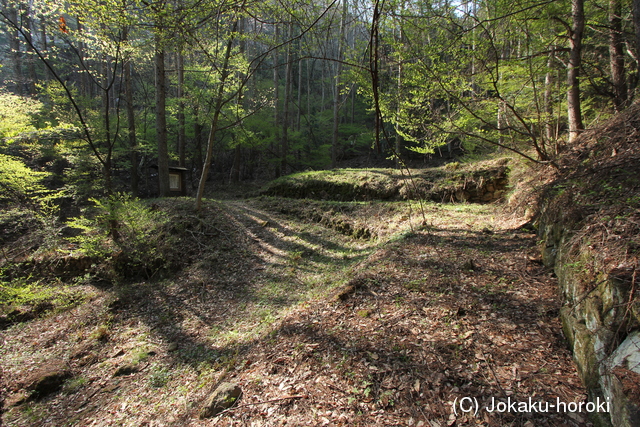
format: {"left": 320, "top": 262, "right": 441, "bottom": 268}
{"left": 539, "top": 211, "right": 640, "bottom": 427}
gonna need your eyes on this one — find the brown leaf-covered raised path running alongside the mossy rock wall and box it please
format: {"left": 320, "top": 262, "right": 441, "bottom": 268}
{"left": 209, "top": 204, "right": 588, "bottom": 426}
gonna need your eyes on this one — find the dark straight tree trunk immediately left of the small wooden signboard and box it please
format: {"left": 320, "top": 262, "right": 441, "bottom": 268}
{"left": 155, "top": 35, "right": 169, "bottom": 197}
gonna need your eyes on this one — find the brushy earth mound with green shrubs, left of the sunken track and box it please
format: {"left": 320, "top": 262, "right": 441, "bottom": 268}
{"left": 0, "top": 198, "right": 252, "bottom": 329}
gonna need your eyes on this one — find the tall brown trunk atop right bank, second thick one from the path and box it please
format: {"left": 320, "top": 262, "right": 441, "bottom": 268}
{"left": 609, "top": 0, "right": 627, "bottom": 111}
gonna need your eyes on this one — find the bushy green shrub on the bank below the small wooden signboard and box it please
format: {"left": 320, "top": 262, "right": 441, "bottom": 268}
{"left": 68, "top": 194, "right": 171, "bottom": 278}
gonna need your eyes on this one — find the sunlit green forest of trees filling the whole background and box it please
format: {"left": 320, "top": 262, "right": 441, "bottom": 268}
{"left": 0, "top": 0, "right": 639, "bottom": 199}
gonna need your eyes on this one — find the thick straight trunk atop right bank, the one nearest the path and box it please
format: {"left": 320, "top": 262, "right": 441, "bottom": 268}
{"left": 567, "top": 0, "right": 585, "bottom": 142}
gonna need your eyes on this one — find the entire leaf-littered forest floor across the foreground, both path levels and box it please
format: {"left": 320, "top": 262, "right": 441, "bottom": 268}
{"left": 0, "top": 197, "right": 589, "bottom": 427}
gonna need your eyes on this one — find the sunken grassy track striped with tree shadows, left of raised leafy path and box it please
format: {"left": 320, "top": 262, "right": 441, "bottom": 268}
{"left": 94, "top": 197, "right": 369, "bottom": 368}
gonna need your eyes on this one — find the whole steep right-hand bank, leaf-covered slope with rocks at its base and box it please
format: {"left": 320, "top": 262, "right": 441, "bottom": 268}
{"left": 539, "top": 104, "right": 640, "bottom": 426}
